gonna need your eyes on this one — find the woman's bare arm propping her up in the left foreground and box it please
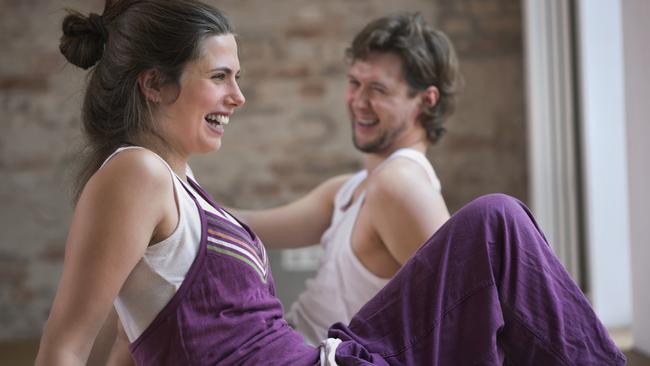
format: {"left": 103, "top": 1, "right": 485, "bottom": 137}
{"left": 36, "top": 150, "right": 178, "bottom": 365}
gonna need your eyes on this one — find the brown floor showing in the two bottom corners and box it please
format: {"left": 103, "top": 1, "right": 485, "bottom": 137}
{"left": 5, "top": 341, "right": 650, "bottom": 366}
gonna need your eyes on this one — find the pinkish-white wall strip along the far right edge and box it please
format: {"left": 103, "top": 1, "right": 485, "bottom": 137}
{"left": 622, "top": 0, "right": 650, "bottom": 354}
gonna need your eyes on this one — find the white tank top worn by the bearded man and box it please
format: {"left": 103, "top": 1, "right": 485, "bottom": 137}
{"left": 287, "top": 148, "right": 440, "bottom": 345}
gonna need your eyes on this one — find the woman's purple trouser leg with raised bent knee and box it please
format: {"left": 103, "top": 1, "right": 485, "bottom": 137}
{"left": 329, "top": 195, "right": 625, "bottom": 365}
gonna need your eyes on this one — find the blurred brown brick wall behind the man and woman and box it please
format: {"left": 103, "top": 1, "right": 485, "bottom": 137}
{"left": 0, "top": 0, "right": 527, "bottom": 339}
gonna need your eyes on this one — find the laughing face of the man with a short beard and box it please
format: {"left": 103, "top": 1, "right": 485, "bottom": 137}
{"left": 346, "top": 53, "right": 424, "bottom": 154}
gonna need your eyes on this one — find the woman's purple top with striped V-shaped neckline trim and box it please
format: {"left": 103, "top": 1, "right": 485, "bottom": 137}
{"left": 129, "top": 178, "right": 320, "bottom": 365}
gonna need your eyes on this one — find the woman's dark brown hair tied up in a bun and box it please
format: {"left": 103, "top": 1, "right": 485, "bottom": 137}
{"left": 60, "top": 0, "right": 233, "bottom": 199}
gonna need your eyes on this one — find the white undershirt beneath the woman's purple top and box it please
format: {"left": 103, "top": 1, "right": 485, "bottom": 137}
{"left": 100, "top": 146, "right": 239, "bottom": 342}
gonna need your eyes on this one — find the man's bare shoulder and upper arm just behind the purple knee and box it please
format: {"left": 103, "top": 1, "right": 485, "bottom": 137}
{"left": 365, "top": 159, "right": 449, "bottom": 265}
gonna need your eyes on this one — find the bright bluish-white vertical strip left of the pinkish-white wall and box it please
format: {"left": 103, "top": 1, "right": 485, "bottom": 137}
{"left": 577, "top": 0, "right": 632, "bottom": 327}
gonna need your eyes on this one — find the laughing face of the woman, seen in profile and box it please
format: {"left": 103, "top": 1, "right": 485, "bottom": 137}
{"left": 159, "top": 34, "right": 245, "bottom": 159}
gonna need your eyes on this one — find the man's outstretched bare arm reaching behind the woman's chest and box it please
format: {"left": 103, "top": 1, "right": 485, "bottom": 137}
{"left": 229, "top": 175, "right": 349, "bottom": 249}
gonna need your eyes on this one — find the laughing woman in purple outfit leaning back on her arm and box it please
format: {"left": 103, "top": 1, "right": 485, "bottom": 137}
{"left": 36, "top": 0, "right": 624, "bottom": 365}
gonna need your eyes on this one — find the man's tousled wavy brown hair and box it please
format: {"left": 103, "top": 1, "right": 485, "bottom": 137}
{"left": 345, "top": 13, "right": 460, "bottom": 143}
